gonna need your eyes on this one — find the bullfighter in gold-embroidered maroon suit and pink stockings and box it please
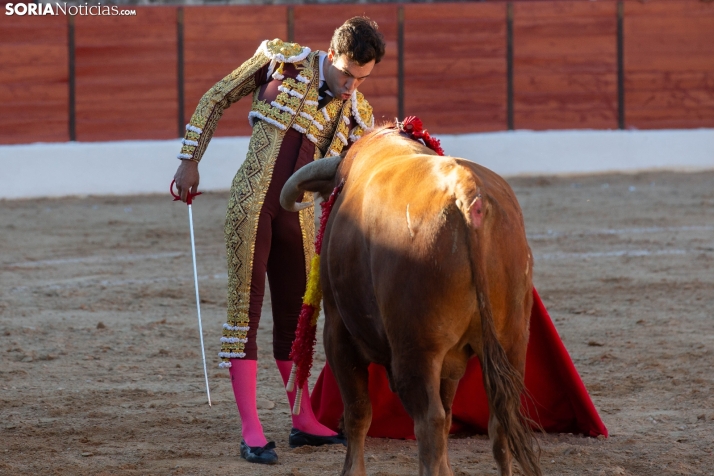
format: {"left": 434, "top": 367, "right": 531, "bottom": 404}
{"left": 174, "top": 17, "right": 385, "bottom": 464}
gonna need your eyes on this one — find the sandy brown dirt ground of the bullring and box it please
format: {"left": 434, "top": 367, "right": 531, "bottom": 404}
{"left": 0, "top": 172, "right": 714, "bottom": 476}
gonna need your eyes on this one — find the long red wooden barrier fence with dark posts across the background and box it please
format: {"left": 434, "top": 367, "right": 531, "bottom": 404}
{"left": 0, "top": 0, "right": 714, "bottom": 144}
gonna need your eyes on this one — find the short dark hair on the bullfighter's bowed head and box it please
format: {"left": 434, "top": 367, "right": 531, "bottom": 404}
{"left": 330, "top": 17, "right": 385, "bottom": 66}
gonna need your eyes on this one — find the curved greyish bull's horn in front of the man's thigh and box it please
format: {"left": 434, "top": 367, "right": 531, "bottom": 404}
{"left": 280, "top": 156, "right": 342, "bottom": 212}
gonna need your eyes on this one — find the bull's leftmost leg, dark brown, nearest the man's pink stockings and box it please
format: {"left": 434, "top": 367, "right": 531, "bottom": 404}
{"left": 325, "top": 302, "right": 372, "bottom": 476}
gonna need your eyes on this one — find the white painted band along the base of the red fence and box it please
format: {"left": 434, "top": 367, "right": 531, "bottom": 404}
{"left": 0, "top": 129, "right": 714, "bottom": 199}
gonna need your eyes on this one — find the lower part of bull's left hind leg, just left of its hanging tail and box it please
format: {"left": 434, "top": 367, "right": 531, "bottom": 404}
{"left": 393, "top": 354, "right": 453, "bottom": 476}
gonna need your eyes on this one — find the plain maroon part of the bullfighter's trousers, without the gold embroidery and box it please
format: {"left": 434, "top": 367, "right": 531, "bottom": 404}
{"left": 244, "top": 129, "right": 315, "bottom": 360}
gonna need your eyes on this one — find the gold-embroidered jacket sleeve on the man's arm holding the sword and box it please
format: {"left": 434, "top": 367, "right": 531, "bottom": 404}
{"left": 180, "top": 51, "right": 270, "bottom": 162}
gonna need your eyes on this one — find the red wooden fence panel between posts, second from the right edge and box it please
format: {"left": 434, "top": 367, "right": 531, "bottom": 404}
{"left": 513, "top": 2, "right": 618, "bottom": 129}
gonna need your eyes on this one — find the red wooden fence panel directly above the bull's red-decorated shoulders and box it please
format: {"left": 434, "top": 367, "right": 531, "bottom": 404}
{"left": 404, "top": 3, "right": 507, "bottom": 133}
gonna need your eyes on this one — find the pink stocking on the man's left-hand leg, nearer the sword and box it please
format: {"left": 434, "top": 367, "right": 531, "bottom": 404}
{"left": 229, "top": 359, "right": 268, "bottom": 446}
